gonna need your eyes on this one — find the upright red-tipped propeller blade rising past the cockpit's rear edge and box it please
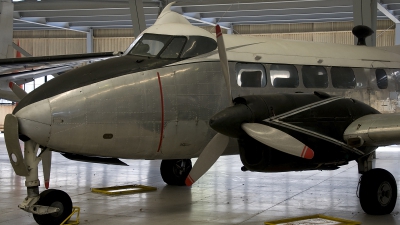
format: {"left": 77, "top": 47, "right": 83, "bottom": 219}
{"left": 215, "top": 25, "right": 232, "bottom": 103}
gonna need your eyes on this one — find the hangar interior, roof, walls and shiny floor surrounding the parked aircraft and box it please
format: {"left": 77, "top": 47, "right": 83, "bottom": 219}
{"left": 0, "top": 0, "right": 400, "bottom": 225}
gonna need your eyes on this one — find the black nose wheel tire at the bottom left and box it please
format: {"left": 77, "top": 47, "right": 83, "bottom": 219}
{"left": 33, "top": 189, "right": 72, "bottom": 225}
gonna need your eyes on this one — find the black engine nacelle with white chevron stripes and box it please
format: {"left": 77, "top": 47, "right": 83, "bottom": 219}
{"left": 210, "top": 92, "right": 379, "bottom": 172}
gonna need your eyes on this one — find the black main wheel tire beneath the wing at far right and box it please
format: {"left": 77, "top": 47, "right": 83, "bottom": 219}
{"left": 360, "top": 169, "right": 397, "bottom": 215}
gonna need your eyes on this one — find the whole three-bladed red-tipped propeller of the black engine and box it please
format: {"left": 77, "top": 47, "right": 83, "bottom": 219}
{"left": 185, "top": 25, "right": 314, "bottom": 186}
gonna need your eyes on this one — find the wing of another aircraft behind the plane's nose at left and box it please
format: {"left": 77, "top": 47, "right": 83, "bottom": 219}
{"left": 0, "top": 52, "right": 120, "bottom": 102}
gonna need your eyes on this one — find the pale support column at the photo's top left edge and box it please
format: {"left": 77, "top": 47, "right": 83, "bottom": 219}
{"left": 0, "top": 0, "right": 14, "bottom": 59}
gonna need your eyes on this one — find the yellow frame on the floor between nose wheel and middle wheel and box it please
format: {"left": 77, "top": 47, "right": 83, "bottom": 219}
{"left": 91, "top": 184, "right": 157, "bottom": 195}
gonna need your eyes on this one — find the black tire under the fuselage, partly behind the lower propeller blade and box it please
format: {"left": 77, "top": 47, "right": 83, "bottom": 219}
{"left": 160, "top": 159, "right": 192, "bottom": 186}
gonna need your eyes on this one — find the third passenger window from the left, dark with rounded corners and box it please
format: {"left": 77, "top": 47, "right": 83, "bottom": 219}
{"left": 301, "top": 66, "right": 328, "bottom": 88}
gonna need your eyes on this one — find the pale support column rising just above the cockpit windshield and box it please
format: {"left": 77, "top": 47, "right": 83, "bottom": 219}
{"left": 129, "top": 0, "right": 146, "bottom": 37}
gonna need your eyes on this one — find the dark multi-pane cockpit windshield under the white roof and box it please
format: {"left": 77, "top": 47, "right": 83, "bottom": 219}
{"left": 129, "top": 34, "right": 217, "bottom": 59}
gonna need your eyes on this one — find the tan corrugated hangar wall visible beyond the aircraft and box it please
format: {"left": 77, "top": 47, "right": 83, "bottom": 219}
{"left": 14, "top": 20, "right": 395, "bottom": 56}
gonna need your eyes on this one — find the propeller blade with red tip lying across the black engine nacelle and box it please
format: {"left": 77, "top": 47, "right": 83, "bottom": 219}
{"left": 242, "top": 123, "right": 314, "bottom": 159}
